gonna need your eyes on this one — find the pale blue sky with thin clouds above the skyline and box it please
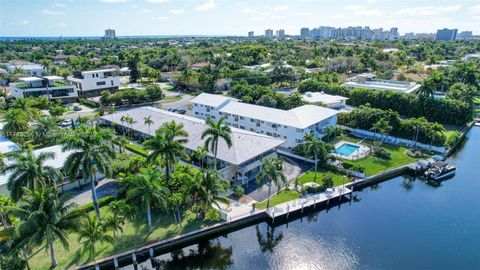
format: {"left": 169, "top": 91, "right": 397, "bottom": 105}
{"left": 0, "top": 0, "right": 480, "bottom": 36}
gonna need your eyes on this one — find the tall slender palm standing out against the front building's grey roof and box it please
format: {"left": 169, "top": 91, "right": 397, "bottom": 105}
{"left": 202, "top": 117, "right": 232, "bottom": 171}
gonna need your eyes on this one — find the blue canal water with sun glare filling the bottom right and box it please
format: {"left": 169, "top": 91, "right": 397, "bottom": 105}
{"left": 136, "top": 127, "right": 480, "bottom": 270}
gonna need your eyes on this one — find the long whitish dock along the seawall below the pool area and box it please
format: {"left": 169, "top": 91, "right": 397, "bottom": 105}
{"left": 266, "top": 186, "right": 352, "bottom": 220}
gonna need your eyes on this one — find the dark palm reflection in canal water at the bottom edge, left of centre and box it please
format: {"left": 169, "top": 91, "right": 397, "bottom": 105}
{"left": 155, "top": 240, "right": 233, "bottom": 269}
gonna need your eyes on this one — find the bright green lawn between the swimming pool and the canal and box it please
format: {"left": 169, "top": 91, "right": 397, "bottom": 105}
{"left": 349, "top": 144, "right": 420, "bottom": 176}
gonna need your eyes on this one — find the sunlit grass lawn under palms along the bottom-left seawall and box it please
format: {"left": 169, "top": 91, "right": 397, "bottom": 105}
{"left": 29, "top": 207, "right": 213, "bottom": 269}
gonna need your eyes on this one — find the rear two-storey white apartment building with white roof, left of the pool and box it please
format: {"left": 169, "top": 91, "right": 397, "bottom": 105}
{"left": 191, "top": 93, "right": 338, "bottom": 149}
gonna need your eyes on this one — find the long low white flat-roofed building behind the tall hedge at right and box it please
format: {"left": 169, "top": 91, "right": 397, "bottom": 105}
{"left": 342, "top": 73, "right": 421, "bottom": 94}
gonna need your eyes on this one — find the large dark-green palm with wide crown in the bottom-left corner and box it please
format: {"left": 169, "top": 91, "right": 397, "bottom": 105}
{"left": 13, "top": 187, "right": 81, "bottom": 268}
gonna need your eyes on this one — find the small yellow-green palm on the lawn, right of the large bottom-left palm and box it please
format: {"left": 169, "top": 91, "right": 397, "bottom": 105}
{"left": 76, "top": 216, "right": 115, "bottom": 260}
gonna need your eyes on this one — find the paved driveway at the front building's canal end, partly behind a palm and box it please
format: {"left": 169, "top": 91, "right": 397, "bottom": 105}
{"left": 243, "top": 156, "right": 313, "bottom": 202}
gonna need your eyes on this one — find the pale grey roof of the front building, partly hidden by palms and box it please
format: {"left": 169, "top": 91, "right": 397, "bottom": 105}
{"left": 102, "top": 107, "right": 285, "bottom": 165}
